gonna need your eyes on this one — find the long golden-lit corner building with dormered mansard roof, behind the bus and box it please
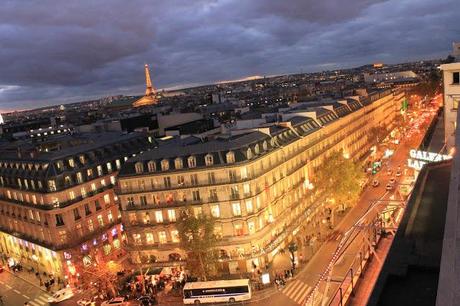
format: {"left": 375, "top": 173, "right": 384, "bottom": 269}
{"left": 117, "top": 91, "right": 403, "bottom": 273}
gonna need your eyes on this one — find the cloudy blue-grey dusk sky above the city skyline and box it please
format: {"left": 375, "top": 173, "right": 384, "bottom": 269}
{"left": 0, "top": 0, "right": 460, "bottom": 111}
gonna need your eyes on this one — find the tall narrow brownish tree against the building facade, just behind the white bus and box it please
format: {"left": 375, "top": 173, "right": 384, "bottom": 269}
{"left": 176, "top": 207, "right": 218, "bottom": 281}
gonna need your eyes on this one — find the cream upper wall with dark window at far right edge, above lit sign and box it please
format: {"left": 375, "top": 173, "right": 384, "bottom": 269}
{"left": 441, "top": 62, "right": 460, "bottom": 150}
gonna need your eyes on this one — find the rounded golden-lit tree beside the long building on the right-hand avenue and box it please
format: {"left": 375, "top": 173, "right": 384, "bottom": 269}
{"left": 314, "top": 151, "right": 364, "bottom": 207}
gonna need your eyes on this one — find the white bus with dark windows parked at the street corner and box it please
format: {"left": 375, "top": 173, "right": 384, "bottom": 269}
{"left": 184, "top": 279, "right": 251, "bottom": 305}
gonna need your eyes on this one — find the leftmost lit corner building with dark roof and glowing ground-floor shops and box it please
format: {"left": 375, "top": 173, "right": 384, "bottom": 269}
{"left": 0, "top": 131, "right": 152, "bottom": 278}
